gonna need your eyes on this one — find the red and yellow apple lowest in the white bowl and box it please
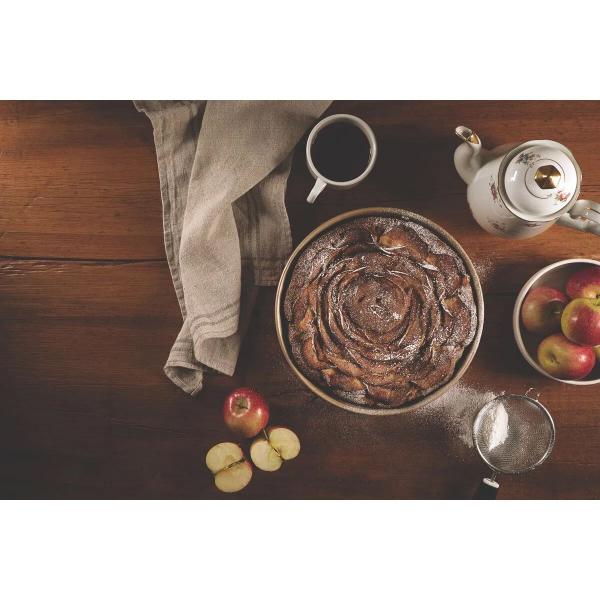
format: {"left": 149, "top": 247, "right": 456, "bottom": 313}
{"left": 538, "top": 333, "right": 596, "bottom": 379}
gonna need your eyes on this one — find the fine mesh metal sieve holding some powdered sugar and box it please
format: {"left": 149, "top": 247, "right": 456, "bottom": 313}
{"left": 473, "top": 388, "right": 555, "bottom": 490}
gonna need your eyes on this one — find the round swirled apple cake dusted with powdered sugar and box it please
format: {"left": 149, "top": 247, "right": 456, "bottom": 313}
{"left": 284, "top": 216, "right": 477, "bottom": 408}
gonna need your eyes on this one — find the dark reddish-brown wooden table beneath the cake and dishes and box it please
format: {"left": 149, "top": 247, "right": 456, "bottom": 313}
{"left": 0, "top": 102, "right": 600, "bottom": 498}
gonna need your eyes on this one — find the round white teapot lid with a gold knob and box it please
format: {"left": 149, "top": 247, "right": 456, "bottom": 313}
{"left": 500, "top": 140, "right": 581, "bottom": 221}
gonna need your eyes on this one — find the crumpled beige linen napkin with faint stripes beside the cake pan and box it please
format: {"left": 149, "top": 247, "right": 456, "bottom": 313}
{"left": 135, "top": 101, "right": 330, "bottom": 394}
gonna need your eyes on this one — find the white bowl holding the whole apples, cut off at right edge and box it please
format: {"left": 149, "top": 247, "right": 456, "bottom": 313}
{"left": 513, "top": 258, "right": 600, "bottom": 385}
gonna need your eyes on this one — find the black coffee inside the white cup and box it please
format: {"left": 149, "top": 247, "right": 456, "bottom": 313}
{"left": 311, "top": 121, "right": 371, "bottom": 181}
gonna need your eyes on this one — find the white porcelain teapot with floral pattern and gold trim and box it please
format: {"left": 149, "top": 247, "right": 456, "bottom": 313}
{"left": 454, "top": 125, "right": 600, "bottom": 239}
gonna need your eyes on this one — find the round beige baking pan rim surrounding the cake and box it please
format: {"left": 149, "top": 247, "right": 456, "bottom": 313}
{"left": 275, "top": 208, "right": 484, "bottom": 415}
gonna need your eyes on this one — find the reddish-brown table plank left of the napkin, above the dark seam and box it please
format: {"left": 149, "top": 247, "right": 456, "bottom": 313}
{"left": 0, "top": 102, "right": 164, "bottom": 259}
